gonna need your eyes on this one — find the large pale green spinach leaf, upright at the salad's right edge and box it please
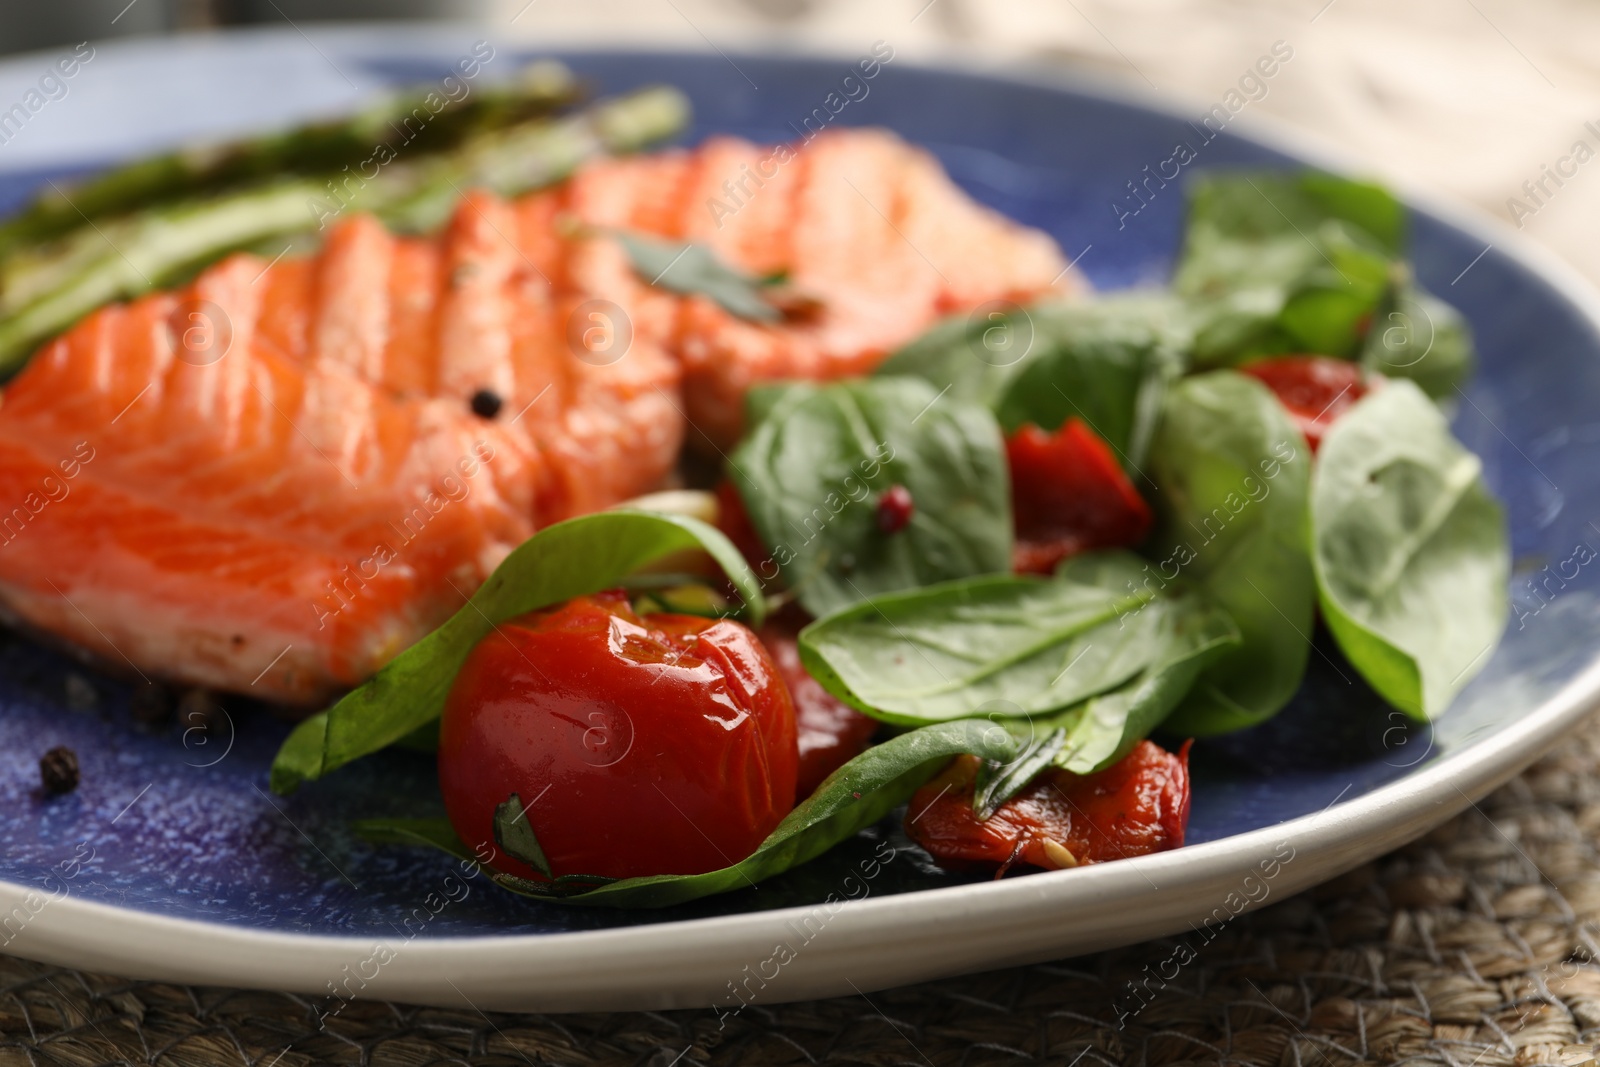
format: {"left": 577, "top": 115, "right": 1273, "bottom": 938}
{"left": 1310, "top": 381, "right": 1510, "bottom": 720}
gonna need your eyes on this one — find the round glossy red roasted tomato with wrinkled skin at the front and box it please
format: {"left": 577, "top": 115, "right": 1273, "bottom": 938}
{"left": 438, "top": 592, "right": 798, "bottom": 878}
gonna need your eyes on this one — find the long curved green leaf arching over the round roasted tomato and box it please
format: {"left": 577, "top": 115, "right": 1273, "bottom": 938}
{"left": 270, "top": 510, "right": 766, "bottom": 793}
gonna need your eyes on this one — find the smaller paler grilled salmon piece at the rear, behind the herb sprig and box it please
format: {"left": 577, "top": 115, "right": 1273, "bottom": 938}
{"left": 563, "top": 128, "right": 1082, "bottom": 448}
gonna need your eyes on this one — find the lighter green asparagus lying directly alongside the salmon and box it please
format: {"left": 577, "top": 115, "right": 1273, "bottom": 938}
{"left": 0, "top": 86, "right": 688, "bottom": 379}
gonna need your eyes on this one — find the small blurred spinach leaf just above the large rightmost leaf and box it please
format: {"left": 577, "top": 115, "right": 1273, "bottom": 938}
{"left": 1362, "top": 272, "right": 1475, "bottom": 400}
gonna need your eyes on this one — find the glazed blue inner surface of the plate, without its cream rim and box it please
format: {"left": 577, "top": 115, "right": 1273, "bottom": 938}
{"left": 0, "top": 30, "right": 1600, "bottom": 939}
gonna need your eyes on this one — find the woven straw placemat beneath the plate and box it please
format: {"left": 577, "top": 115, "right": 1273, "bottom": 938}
{"left": 0, "top": 718, "right": 1600, "bottom": 1067}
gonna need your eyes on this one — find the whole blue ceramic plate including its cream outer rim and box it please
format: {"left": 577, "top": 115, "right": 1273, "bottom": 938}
{"left": 0, "top": 29, "right": 1600, "bottom": 1011}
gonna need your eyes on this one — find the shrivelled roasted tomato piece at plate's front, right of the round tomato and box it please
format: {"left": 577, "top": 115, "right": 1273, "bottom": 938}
{"left": 906, "top": 741, "right": 1189, "bottom": 877}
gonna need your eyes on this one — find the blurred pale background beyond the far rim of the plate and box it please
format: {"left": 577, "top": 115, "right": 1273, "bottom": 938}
{"left": 0, "top": 0, "right": 1600, "bottom": 282}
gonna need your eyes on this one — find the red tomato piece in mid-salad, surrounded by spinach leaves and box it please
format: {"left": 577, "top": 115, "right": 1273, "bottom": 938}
{"left": 1005, "top": 419, "right": 1150, "bottom": 574}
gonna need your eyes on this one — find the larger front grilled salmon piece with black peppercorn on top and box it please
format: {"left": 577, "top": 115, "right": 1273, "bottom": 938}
{"left": 0, "top": 194, "right": 683, "bottom": 704}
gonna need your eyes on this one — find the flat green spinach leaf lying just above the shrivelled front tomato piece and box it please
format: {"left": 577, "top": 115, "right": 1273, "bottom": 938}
{"left": 800, "top": 552, "right": 1238, "bottom": 748}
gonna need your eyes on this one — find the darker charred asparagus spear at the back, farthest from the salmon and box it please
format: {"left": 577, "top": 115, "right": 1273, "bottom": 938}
{"left": 0, "top": 62, "right": 578, "bottom": 258}
